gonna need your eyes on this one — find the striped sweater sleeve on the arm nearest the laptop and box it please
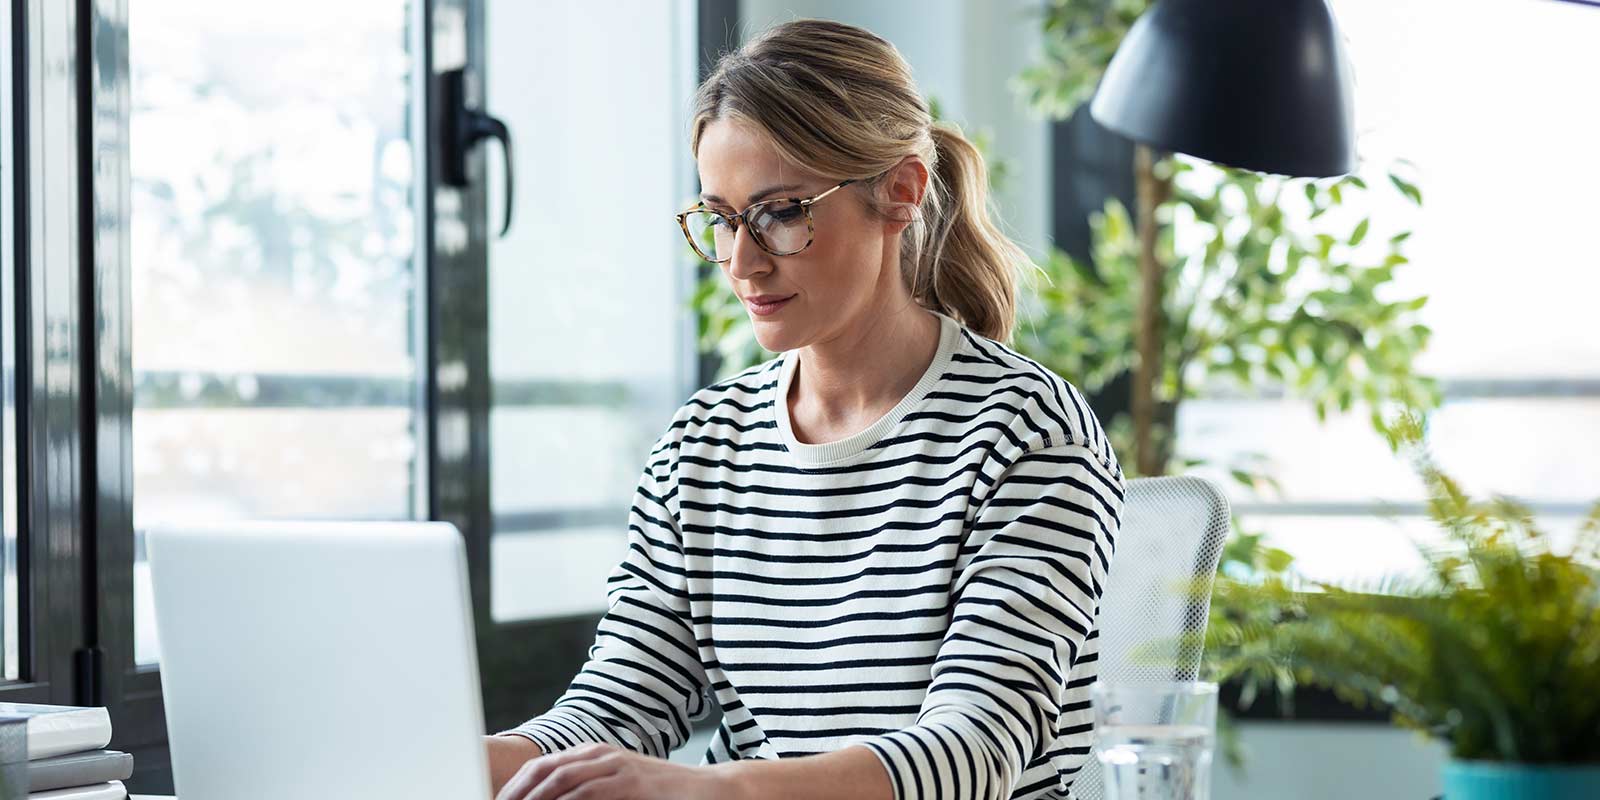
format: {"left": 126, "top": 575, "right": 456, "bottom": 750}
{"left": 501, "top": 432, "right": 709, "bottom": 758}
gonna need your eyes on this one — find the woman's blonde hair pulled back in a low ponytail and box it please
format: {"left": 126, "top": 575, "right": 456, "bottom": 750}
{"left": 690, "top": 19, "right": 1029, "bottom": 341}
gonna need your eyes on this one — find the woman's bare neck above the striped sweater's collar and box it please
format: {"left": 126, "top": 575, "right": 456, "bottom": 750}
{"left": 786, "top": 298, "right": 939, "bottom": 445}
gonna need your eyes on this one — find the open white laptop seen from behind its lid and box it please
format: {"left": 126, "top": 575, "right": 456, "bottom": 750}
{"left": 146, "top": 522, "right": 490, "bottom": 800}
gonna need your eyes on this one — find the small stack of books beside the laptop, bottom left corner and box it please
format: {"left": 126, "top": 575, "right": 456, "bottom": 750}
{"left": 0, "top": 702, "right": 133, "bottom": 800}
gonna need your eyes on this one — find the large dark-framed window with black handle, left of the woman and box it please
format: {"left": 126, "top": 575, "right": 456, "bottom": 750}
{"left": 0, "top": 0, "right": 696, "bottom": 794}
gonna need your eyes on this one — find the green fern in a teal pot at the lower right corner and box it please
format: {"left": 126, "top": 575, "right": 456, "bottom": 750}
{"left": 1206, "top": 416, "right": 1600, "bottom": 800}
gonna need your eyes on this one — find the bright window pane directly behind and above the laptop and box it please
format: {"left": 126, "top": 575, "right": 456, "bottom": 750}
{"left": 130, "top": 0, "right": 427, "bottom": 664}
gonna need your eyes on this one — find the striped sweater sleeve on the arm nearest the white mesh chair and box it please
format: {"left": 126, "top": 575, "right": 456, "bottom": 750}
{"left": 859, "top": 445, "right": 1125, "bottom": 800}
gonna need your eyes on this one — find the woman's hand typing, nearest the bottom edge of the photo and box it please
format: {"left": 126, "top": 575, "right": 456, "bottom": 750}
{"left": 496, "top": 744, "right": 739, "bottom": 800}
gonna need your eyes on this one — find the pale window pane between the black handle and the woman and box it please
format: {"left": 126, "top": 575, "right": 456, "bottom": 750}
{"left": 485, "top": 0, "right": 694, "bottom": 621}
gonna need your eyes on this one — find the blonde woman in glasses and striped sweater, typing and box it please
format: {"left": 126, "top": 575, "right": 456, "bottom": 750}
{"left": 488, "top": 21, "right": 1123, "bottom": 800}
